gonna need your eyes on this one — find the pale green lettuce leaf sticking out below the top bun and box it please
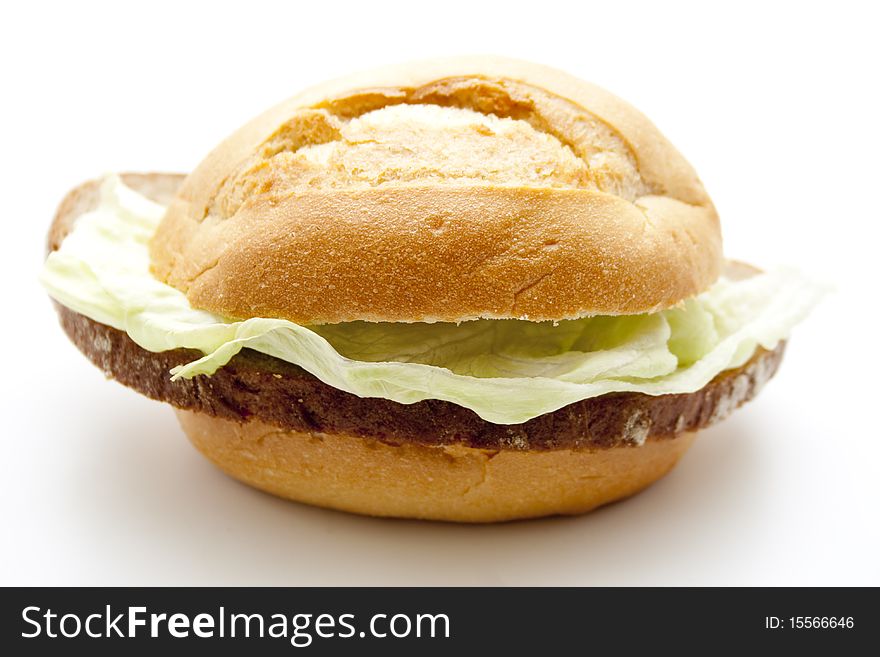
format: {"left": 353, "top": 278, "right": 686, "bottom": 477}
{"left": 41, "top": 176, "right": 823, "bottom": 424}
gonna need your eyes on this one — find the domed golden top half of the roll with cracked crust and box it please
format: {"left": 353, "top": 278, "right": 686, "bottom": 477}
{"left": 151, "top": 58, "right": 722, "bottom": 324}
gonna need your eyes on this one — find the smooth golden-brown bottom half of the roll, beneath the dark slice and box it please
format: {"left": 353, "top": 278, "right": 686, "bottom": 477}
{"left": 176, "top": 410, "right": 696, "bottom": 522}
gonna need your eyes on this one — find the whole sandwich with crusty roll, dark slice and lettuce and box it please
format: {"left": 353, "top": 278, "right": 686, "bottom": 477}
{"left": 42, "top": 58, "right": 821, "bottom": 522}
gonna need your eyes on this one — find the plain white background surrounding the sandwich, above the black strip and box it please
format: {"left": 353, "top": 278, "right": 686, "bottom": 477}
{"left": 0, "top": 0, "right": 880, "bottom": 584}
